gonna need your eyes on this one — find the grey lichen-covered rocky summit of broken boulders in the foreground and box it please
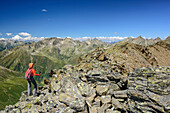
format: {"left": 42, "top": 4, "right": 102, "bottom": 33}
{"left": 1, "top": 48, "right": 170, "bottom": 113}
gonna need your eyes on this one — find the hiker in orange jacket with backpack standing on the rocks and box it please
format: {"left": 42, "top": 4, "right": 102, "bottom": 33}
{"left": 25, "top": 63, "right": 41, "bottom": 96}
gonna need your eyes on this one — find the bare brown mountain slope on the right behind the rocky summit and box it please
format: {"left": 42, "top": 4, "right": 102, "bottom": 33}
{"left": 106, "top": 38, "right": 170, "bottom": 71}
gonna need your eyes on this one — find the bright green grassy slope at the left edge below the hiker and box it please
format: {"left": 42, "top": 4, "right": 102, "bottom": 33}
{"left": 0, "top": 66, "right": 27, "bottom": 110}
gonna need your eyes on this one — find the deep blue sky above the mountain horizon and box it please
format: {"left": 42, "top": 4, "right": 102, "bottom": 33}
{"left": 0, "top": 0, "right": 170, "bottom": 38}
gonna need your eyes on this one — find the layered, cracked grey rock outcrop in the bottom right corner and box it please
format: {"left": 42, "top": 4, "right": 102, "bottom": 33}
{"left": 128, "top": 67, "right": 170, "bottom": 113}
